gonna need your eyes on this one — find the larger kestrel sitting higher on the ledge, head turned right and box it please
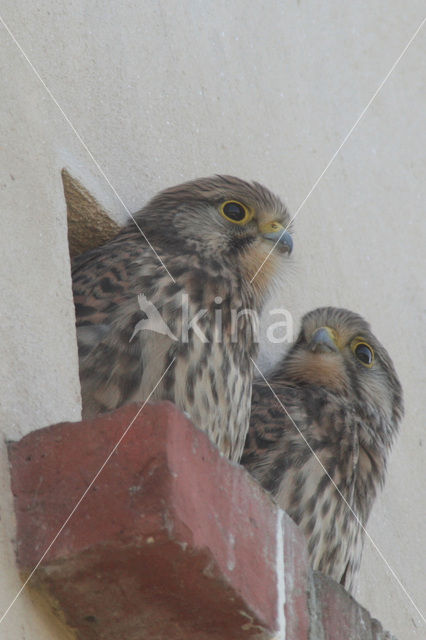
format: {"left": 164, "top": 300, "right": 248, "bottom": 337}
{"left": 72, "top": 176, "right": 292, "bottom": 461}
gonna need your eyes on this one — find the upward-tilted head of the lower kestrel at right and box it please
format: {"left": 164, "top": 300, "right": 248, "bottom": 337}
{"left": 285, "top": 307, "right": 403, "bottom": 425}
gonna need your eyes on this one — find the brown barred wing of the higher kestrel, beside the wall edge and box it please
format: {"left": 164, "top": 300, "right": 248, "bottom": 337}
{"left": 72, "top": 238, "right": 169, "bottom": 417}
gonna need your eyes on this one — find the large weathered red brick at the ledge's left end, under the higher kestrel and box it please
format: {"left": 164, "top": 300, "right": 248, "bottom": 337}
{"left": 9, "top": 403, "right": 300, "bottom": 640}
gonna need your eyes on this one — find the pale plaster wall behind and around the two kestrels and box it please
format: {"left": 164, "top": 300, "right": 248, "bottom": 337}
{"left": 0, "top": 0, "right": 426, "bottom": 640}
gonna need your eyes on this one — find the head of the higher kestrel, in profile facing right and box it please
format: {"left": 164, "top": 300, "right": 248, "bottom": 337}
{"left": 138, "top": 176, "right": 293, "bottom": 300}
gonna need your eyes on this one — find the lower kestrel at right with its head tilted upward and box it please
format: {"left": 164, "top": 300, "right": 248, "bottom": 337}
{"left": 241, "top": 307, "right": 403, "bottom": 592}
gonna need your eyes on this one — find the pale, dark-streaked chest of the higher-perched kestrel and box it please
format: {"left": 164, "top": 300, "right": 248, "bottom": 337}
{"left": 174, "top": 300, "right": 257, "bottom": 459}
